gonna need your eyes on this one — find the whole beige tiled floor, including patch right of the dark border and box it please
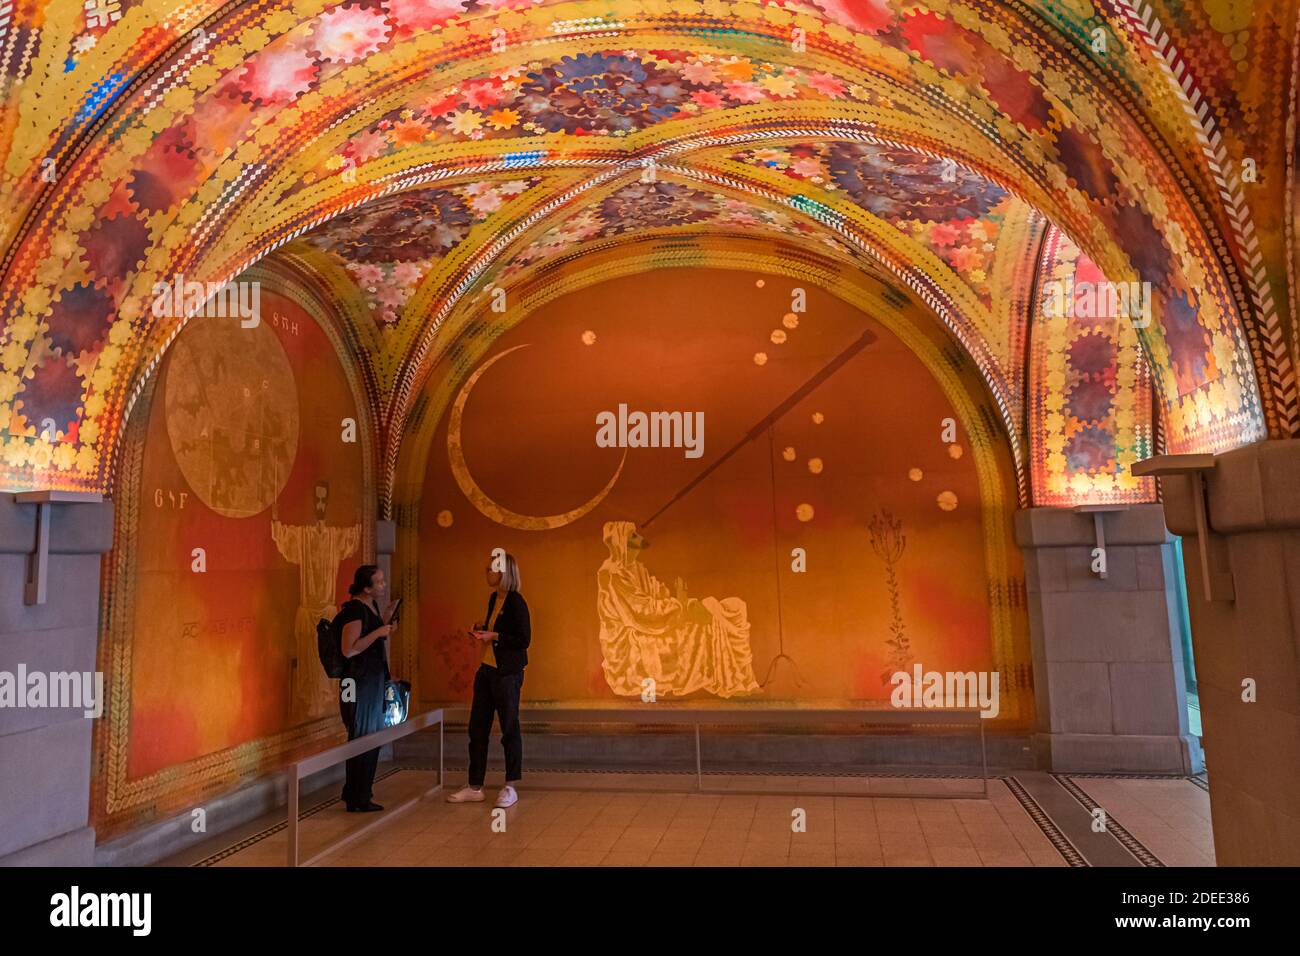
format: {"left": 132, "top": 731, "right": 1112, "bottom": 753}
{"left": 175, "top": 769, "right": 1214, "bottom": 866}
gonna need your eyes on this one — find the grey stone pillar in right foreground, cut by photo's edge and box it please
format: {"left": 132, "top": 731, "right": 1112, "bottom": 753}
{"left": 1161, "top": 440, "right": 1300, "bottom": 866}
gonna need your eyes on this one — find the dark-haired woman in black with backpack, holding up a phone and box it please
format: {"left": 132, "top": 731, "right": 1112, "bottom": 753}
{"left": 335, "top": 564, "right": 397, "bottom": 813}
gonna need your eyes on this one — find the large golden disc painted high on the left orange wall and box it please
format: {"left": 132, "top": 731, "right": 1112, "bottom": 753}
{"left": 164, "top": 317, "right": 298, "bottom": 518}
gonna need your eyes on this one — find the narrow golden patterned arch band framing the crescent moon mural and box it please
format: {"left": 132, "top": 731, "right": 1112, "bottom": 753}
{"left": 393, "top": 235, "right": 1032, "bottom": 724}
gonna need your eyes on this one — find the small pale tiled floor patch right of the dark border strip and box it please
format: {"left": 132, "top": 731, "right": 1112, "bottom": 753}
{"left": 1070, "top": 777, "right": 1214, "bottom": 866}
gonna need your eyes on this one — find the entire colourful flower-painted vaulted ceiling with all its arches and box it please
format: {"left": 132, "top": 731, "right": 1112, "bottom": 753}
{"left": 0, "top": 0, "right": 1300, "bottom": 503}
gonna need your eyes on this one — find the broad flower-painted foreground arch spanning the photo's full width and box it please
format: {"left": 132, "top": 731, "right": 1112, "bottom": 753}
{"left": 0, "top": 0, "right": 1274, "bottom": 486}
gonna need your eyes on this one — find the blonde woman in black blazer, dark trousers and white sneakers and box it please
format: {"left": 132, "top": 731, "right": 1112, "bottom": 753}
{"left": 447, "top": 554, "right": 533, "bottom": 806}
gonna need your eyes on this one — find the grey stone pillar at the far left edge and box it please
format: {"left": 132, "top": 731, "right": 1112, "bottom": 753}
{"left": 0, "top": 493, "right": 113, "bottom": 866}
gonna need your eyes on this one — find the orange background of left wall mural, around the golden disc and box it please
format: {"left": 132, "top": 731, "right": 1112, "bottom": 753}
{"left": 125, "top": 293, "right": 365, "bottom": 778}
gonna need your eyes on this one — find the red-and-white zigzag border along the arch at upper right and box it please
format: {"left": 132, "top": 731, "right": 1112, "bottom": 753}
{"left": 1110, "top": 0, "right": 1300, "bottom": 437}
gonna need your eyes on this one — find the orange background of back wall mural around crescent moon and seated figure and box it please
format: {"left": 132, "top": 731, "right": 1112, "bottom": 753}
{"left": 419, "top": 269, "right": 1019, "bottom": 701}
